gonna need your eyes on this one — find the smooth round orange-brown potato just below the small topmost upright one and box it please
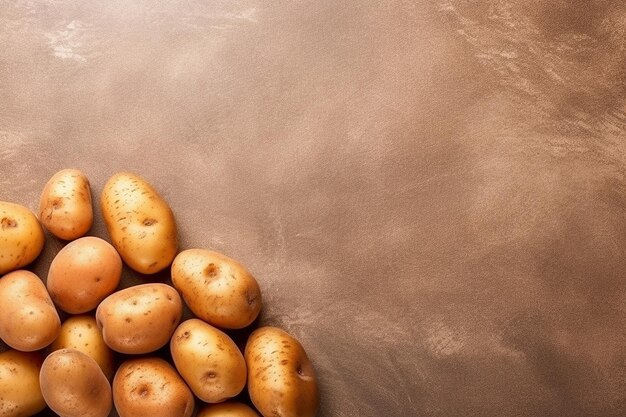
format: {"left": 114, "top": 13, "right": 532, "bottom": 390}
{"left": 46, "top": 236, "right": 122, "bottom": 314}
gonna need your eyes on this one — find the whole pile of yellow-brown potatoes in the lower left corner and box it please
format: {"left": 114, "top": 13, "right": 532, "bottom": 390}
{"left": 0, "top": 169, "right": 319, "bottom": 417}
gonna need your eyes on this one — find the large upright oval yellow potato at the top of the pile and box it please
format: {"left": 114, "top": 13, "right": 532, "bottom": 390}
{"left": 101, "top": 172, "right": 178, "bottom": 274}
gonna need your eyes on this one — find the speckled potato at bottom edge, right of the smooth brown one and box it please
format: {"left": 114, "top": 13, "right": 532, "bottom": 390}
{"left": 113, "top": 358, "right": 195, "bottom": 417}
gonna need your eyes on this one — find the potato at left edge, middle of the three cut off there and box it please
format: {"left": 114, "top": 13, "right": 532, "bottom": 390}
{"left": 0, "top": 270, "right": 61, "bottom": 352}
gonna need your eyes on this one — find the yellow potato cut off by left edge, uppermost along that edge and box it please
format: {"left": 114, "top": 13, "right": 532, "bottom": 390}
{"left": 0, "top": 201, "right": 45, "bottom": 275}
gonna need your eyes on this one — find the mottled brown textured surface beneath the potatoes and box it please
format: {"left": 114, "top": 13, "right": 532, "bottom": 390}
{"left": 0, "top": 0, "right": 626, "bottom": 417}
